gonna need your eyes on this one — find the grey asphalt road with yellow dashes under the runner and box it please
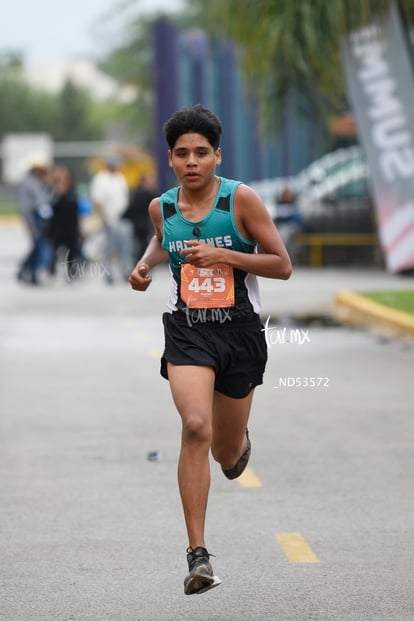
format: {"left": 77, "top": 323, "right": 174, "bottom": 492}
{"left": 0, "top": 227, "right": 414, "bottom": 621}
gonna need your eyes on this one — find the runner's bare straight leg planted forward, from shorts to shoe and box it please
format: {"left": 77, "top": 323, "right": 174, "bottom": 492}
{"left": 168, "top": 363, "right": 215, "bottom": 549}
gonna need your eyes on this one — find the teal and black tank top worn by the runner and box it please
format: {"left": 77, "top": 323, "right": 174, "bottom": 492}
{"left": 160, "top": 177, "right": 260, "bottom": 324}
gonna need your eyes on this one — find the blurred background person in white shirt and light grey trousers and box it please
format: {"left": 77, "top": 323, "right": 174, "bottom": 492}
{"left": 90, "top": 156, "right": 134, "bottom": 284}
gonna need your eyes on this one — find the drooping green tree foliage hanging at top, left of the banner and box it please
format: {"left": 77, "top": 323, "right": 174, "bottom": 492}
{"left": 188, "top": 0, "right": 414, "bottom": 124}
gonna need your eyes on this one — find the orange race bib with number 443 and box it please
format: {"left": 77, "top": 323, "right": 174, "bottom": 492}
{"left": 181, "top": 263, "right": 234, "bottom": 308}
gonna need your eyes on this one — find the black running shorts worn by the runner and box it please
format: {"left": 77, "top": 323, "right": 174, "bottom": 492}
{"left": 160, "top": 313, "right": 267, "bottom": 399}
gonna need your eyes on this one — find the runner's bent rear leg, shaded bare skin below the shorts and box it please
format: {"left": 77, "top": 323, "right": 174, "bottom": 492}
{"left": 211, "top": 389, "right": 254, "bottom": 469}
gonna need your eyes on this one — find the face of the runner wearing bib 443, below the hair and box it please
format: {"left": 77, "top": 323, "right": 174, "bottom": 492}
{"left": 168, "top": 133, "right": 221, "bottom": 190}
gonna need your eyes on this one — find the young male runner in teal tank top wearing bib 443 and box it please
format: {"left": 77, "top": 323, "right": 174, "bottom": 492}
{"left": 129, "top": 104, "right": 292, "bottom": 595}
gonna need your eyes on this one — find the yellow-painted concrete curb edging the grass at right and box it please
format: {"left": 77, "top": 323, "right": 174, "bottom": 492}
{"left": 335, "top": 291, "right": 414, "bottom": 338}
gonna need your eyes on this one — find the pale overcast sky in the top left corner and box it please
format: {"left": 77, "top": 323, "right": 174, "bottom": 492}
{"left": 0, "top": 0, "right": 183, "bottom": 64}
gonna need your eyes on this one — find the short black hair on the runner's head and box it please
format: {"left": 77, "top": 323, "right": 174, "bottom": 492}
{"left": 163, "top": 104, "right": 221, "bottom": 151}
